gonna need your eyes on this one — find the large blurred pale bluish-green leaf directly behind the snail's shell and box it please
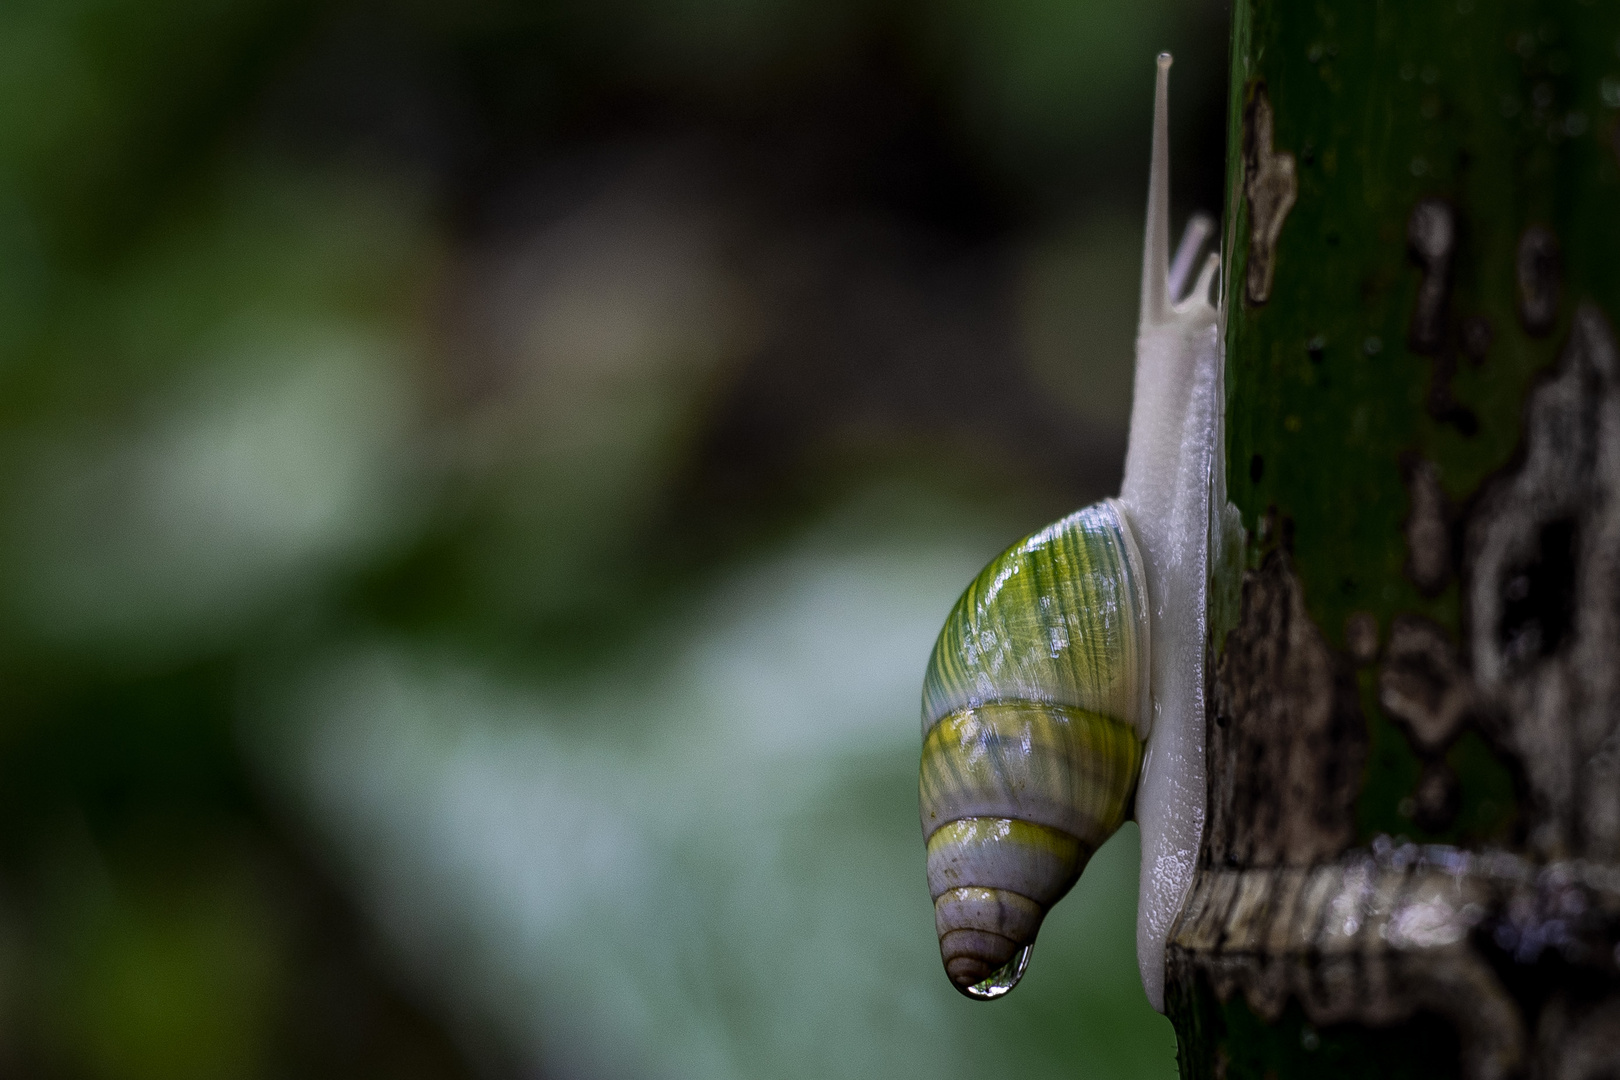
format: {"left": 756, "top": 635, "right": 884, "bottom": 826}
{"left": 253, "top": 494, "right": 1173, "bottom": 1080}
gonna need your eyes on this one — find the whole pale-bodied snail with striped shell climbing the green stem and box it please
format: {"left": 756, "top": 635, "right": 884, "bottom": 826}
{"left": 919, "top": 53, "right": 1230, "bottom": 1010}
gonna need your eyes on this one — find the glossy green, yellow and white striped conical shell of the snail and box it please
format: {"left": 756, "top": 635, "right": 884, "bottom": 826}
{"left": 919, "top": 499, "right": 1150, "bottom": 999}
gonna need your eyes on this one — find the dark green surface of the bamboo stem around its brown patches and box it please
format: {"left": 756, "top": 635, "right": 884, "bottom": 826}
{"left": 1181, "top": 0, "right": 1620, "bottom": 1077}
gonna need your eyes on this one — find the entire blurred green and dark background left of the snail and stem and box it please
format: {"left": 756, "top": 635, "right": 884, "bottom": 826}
{"left": 0, "top": 0, "right": 1226, "bottom": 1080}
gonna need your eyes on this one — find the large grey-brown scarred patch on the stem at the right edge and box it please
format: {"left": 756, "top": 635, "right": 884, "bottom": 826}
{"left": 1464, "top": 304, "right": 1620, "bottom": 860}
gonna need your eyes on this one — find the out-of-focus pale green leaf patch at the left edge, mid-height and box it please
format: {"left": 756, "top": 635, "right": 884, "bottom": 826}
{"left": 0, "top": 169, "right": 437, "bottom": 659}
